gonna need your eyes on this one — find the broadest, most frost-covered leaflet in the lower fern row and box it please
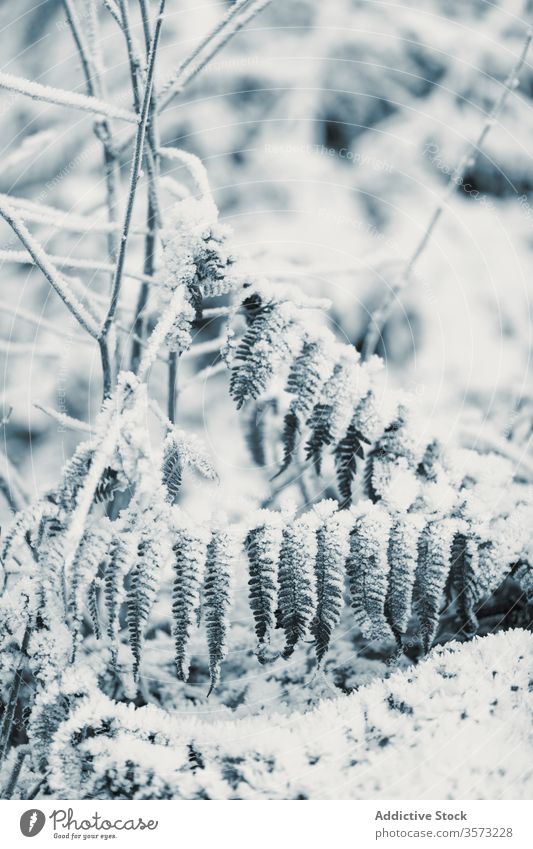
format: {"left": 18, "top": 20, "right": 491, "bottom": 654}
{"left": 346, "top": 506, "right": 391, "bottom": 639}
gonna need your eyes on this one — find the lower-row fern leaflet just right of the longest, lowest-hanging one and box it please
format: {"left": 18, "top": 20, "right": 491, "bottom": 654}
{"left": 244, "top": 511, "right": 281, "bottom": 662}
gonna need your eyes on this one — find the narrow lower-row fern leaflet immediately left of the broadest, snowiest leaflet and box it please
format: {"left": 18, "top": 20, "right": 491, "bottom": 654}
{"left": 310, "top": 502, "right": 348, "bottom": 665}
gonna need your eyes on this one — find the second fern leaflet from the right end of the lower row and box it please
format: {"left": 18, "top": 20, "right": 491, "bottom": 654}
{"left": 413, "top": 519, "right": 463, "bottom": 651}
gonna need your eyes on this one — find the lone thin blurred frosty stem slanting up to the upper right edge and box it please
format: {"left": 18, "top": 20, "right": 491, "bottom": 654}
{"left": 362, "top": 29, "right": 533, "bottom": 360}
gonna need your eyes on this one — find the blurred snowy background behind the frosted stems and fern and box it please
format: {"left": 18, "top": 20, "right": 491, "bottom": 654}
{"left": 0, "top": 0, "right": 533, "bottom": 716}
